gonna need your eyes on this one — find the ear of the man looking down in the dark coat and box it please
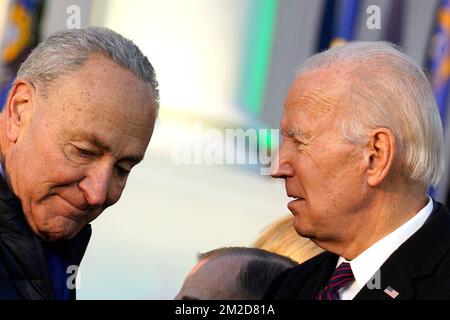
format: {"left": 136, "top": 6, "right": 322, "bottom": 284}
{"left": 4, "top": 79, "right": 36, "bottom": 143}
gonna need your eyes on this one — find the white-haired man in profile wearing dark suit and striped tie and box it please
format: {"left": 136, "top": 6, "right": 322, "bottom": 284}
{"left": 265, "top": 42, "right": 450, "bottom": 300}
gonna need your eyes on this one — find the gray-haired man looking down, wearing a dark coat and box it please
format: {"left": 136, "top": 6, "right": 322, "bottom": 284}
{"left": 0, "top": 27, "right": 158, "bottom": 299}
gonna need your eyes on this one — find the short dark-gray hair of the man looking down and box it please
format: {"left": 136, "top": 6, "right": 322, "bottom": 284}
{"left": 17, "top": 27, "right": 159, "bottom": 106}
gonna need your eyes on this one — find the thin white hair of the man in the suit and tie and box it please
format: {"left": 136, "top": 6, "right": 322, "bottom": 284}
{"left": 297, "top": 42, "right": 444, "bottom": 187}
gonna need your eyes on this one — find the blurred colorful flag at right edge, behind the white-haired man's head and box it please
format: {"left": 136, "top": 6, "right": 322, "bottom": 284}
{"left": 428, "top": 0, "right": 450, "bottom": 200}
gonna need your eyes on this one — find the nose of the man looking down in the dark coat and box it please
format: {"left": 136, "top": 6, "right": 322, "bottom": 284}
{"left": 78, "top": 167, "right": 112, "bottom": 207}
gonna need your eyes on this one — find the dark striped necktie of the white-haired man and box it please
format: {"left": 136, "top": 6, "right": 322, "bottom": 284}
{"left": 317, "top": 262, "right": 355, "bottom": 300}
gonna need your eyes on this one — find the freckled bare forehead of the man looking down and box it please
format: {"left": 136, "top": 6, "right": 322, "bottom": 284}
{"left": 39, "top": 60, "right": 156, "bottom": 138}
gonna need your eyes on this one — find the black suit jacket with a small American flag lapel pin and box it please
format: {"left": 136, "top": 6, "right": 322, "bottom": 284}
{"left": 264, "top": 201, "right": 450, "bottom": 300}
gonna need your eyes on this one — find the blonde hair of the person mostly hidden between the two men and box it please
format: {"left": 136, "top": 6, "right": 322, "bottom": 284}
{"left": 253, "top": 214, "right": 324, "bottom": 263}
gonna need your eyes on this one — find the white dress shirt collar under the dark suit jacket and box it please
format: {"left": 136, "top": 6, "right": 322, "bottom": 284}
{"left": 336, "top": 197, "right": 433, "bottom": 300}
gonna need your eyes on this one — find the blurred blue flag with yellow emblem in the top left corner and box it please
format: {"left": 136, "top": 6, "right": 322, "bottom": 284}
{"left": 0, "top": 0, "right": 44, "bottom": 110}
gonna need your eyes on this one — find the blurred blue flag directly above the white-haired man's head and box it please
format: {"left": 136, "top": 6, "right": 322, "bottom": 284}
{"left": 318, "top": 0, "right": 361, "bottom": 51}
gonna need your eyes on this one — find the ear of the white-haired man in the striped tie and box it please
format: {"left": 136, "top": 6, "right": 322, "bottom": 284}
{"left": 367, "top": 128, "right": 396, "bottom": 187}
